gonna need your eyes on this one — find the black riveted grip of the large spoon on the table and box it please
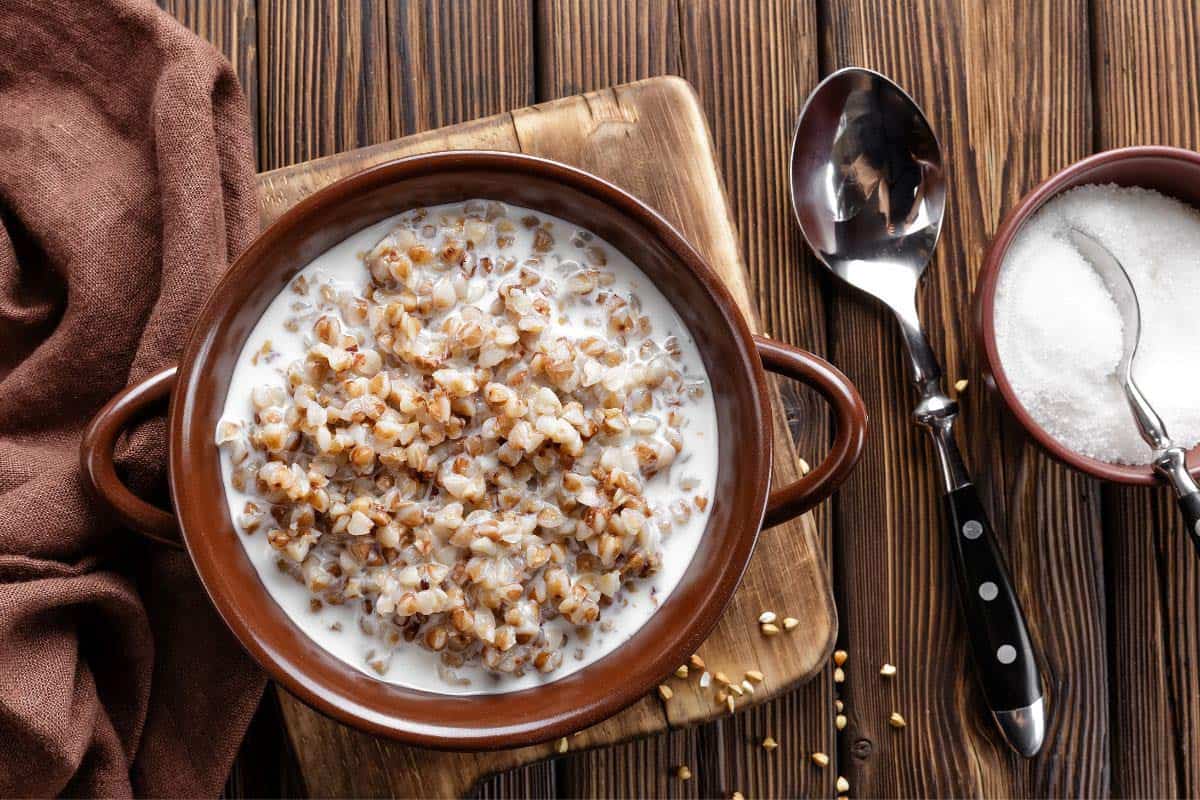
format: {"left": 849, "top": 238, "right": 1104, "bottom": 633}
{"left": 946, "top": 483, "right": 1042, "bottom": 712}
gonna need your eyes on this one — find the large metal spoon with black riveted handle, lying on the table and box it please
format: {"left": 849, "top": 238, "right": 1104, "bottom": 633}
{"left": 792, "top": 67, "right": 1045, "bottom": 757}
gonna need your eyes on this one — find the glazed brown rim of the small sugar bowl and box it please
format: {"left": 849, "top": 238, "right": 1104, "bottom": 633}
{"left": 974, "top": 145, "right": 1200, "bottom": 486}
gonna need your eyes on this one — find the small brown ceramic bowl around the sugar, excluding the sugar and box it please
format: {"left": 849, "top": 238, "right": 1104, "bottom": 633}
{"left": 974, "top": 146, "right": 1200, "bottom": 485}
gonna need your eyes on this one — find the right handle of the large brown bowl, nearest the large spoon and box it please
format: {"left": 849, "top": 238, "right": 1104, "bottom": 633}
{"left": 754, "top": 336, "right": 866, "bottom": 528}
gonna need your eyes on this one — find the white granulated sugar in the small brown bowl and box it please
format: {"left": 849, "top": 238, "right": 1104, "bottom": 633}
{"left": 995, "top": 186, "right": 1200, "bottom": 464}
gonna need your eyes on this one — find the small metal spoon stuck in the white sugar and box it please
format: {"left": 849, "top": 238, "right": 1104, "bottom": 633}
{"left": 1067, "top": 228, "right": 1200, "bottom": 549}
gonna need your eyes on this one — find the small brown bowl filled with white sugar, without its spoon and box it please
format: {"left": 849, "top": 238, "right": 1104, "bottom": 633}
{"left": 974, "top": 146, "right": 1200, "bottom": 485}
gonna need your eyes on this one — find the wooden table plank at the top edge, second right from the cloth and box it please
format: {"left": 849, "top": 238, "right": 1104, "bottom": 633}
{"left": 258, "top": 0, "right": 391, "bottom": 169}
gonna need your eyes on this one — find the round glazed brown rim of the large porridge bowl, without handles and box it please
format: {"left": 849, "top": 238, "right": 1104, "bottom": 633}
{"left": 169, "top": 151, "right": 772, "bottom": 750}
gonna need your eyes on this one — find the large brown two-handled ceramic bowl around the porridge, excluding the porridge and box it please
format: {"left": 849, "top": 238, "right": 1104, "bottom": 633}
{"left": 83, "top": 152, "right": 866, "bottom": 750}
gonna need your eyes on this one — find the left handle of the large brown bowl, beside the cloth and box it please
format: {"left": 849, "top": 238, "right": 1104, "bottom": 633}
{"left": 79, "top": 367, "right": 182, "bottom": 548}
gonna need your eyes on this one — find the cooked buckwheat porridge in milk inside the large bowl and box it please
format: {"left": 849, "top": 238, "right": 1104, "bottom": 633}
{"left": 215, "top": 200, "right": 718, "bottom": 693}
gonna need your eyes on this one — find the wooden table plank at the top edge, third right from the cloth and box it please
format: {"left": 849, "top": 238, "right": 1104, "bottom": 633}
{"left": 388, "top": 0, "right": 535, "bottom": 137}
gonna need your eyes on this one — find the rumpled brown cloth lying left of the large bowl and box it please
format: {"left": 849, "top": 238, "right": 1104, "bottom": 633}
{"left": 0, "top": 0, "right": 264, "bottom": 796}
